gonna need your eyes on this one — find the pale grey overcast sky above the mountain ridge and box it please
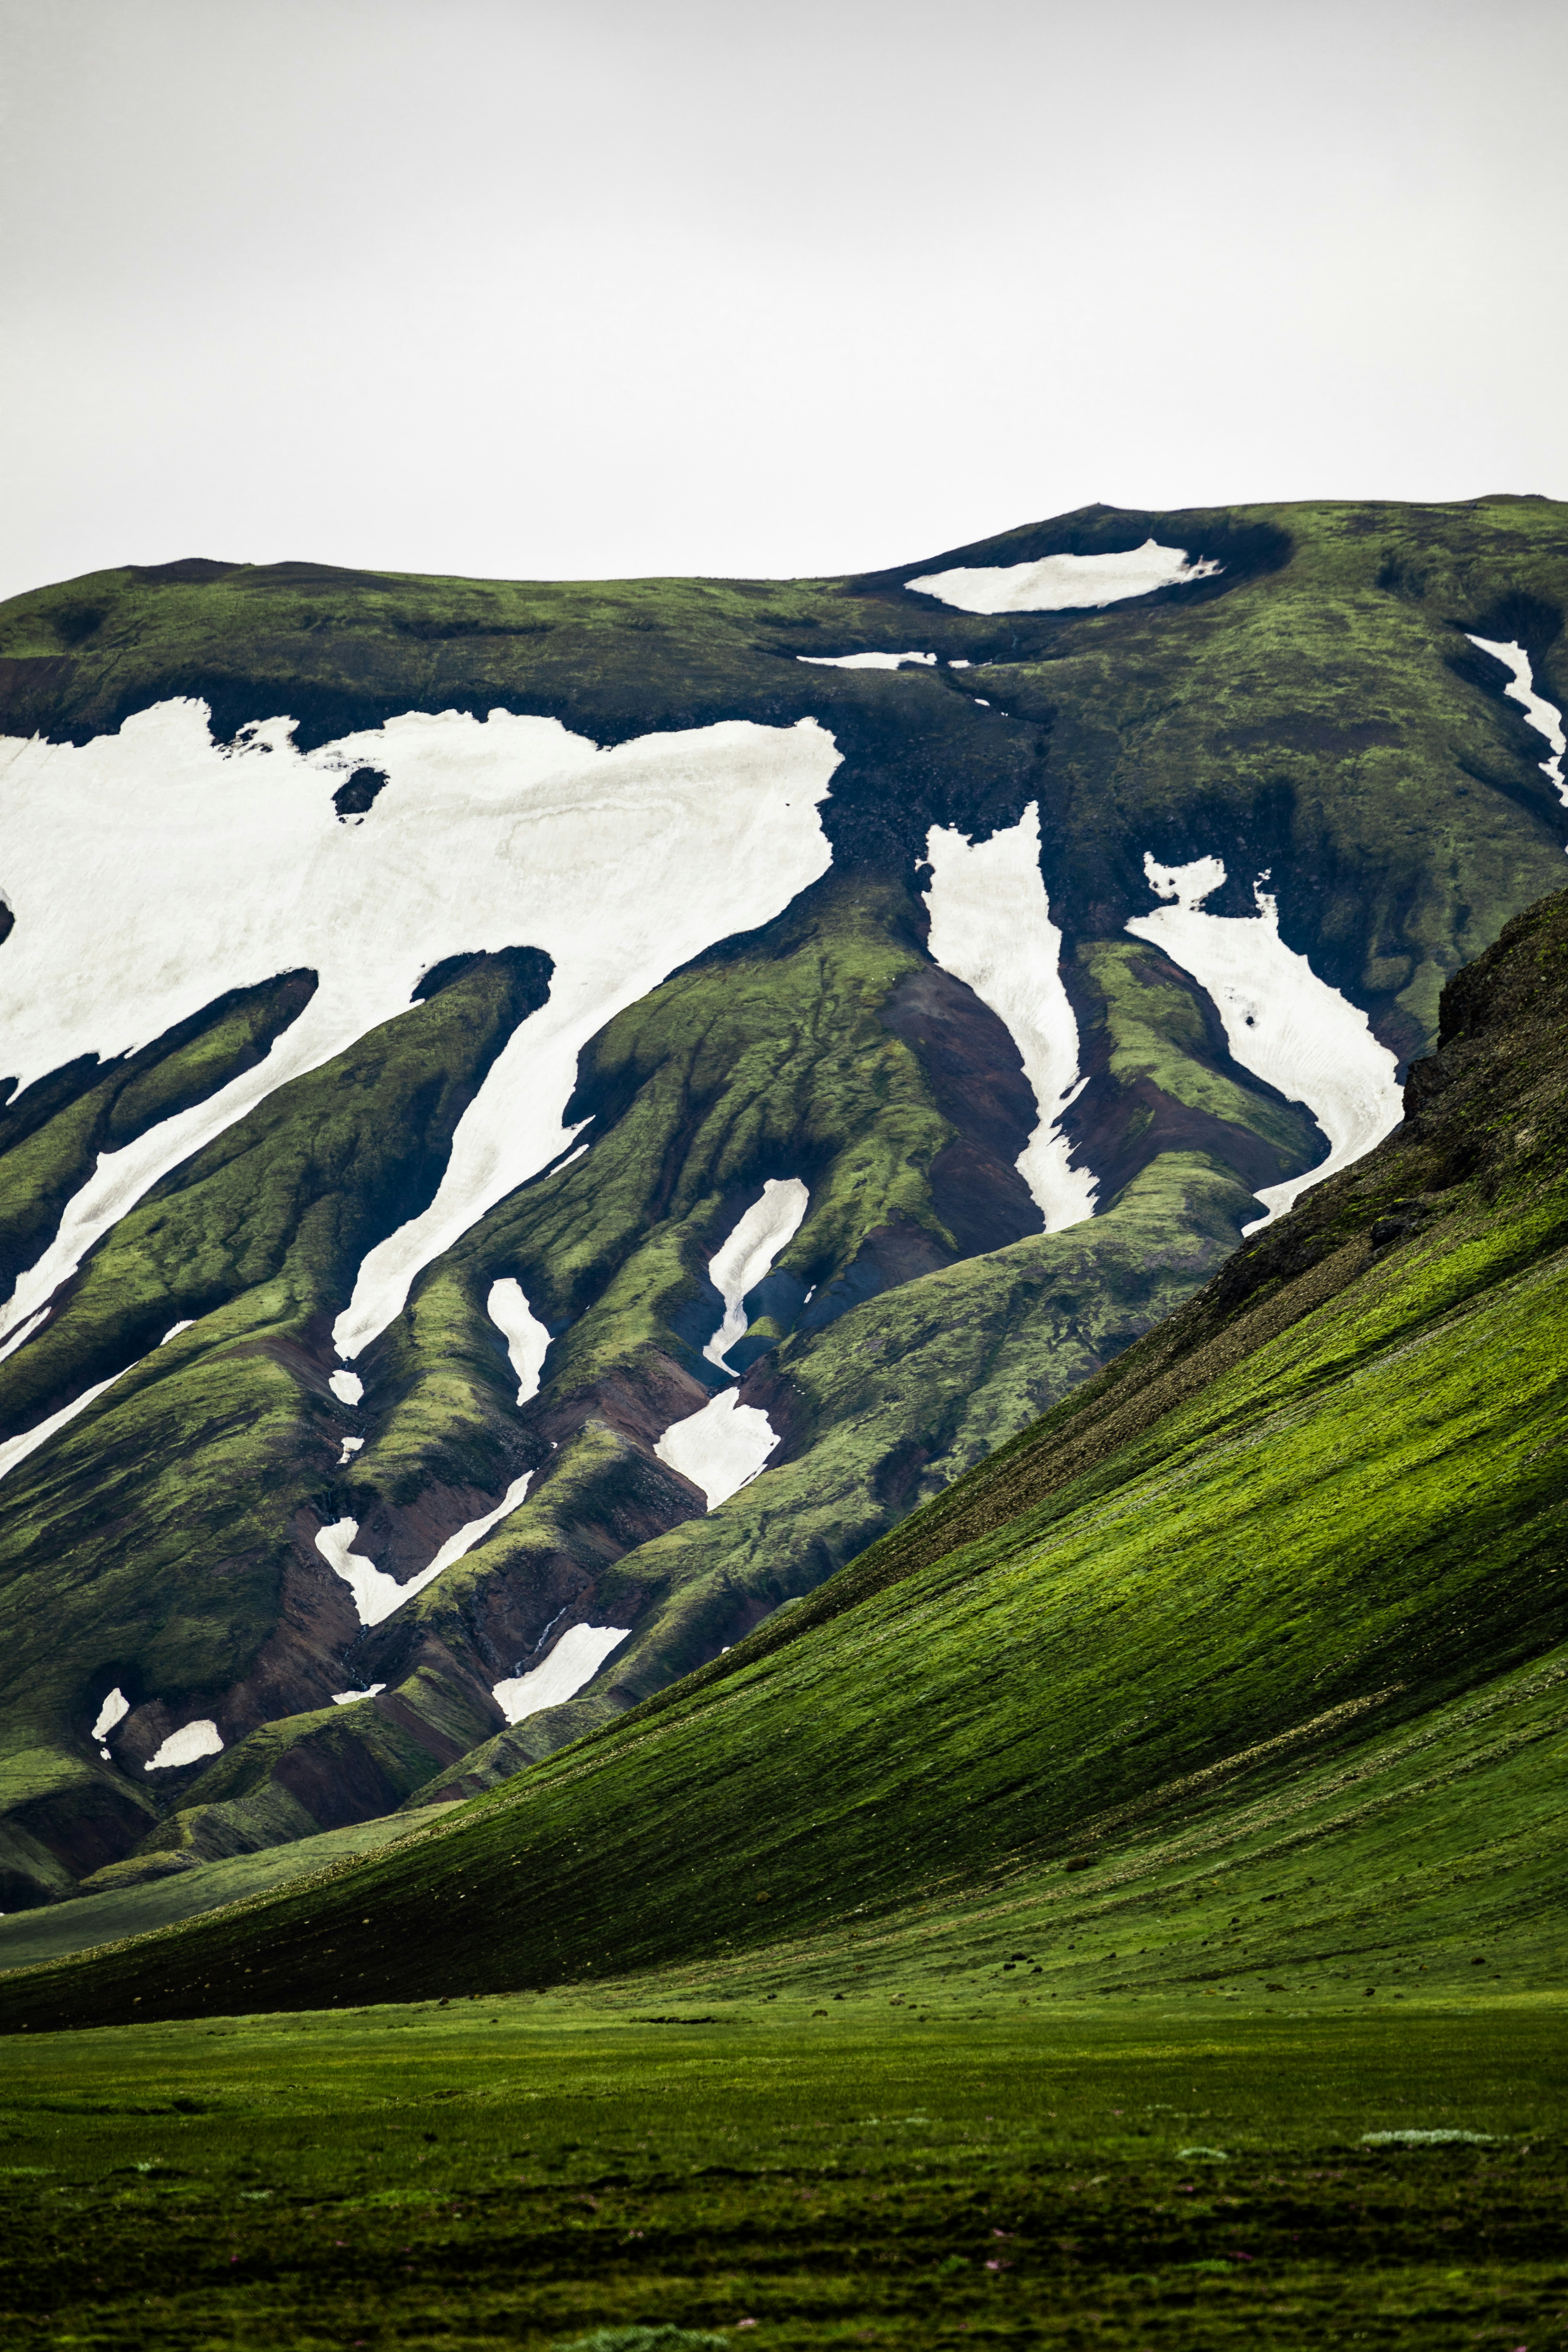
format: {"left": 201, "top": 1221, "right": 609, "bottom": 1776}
{"left": 0, "top": 0, "right": 1568, "bottom": 595}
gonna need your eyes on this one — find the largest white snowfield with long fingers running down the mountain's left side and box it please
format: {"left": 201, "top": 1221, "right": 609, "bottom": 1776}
{"left": 0, "top": 701, "right": 839, "bottom": 1359}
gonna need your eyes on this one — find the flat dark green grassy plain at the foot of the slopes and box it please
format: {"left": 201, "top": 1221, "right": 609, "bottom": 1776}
{"left": 0, "top": 1983, "right": 1568, "bottom": 2352}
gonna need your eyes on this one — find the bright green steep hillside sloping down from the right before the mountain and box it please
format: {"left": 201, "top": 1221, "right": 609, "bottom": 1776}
{"left": 0, "top": 891, "right": 1568, "bottom": 2028}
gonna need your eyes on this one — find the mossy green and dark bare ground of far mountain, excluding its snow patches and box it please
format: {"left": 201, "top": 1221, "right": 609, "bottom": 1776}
{"left": 0, "top": 499, "right": 1568, "bottom": 1903}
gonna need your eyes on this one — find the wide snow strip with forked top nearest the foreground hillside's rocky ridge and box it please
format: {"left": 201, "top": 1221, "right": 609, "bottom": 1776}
{"left": 1126, "top": 852, "right": 1404, "bottom": 1232}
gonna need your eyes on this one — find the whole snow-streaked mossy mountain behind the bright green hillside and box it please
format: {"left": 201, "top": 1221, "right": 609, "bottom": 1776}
{"left": 0, "top": 499, "right": 1568, "bottom": 1910}
